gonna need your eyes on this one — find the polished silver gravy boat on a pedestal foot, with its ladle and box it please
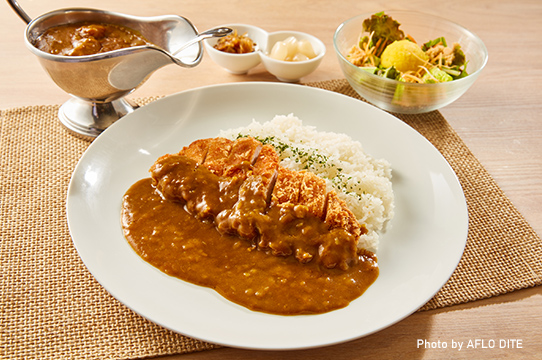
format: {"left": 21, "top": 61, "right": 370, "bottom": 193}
{"left": 8, "top": 0, "right": 232, "bottom": 139}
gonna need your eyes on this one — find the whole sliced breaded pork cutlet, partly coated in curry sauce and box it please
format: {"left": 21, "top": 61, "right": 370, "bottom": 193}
{"left": 152, "top": 137, "right": 367, "bottom": 269}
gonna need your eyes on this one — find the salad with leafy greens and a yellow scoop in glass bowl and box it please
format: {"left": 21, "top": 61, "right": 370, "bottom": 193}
{"left": 347, "top": 12, "right": 468, "bottom": 83}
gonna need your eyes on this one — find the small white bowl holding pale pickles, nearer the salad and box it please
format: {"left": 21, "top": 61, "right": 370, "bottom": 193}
{"left": 260, "top": 31, "right": 326, "bottom": 82}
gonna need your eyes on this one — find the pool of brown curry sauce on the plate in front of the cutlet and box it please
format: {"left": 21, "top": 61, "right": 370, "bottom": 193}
{"left": 122, "top": 178, "right": 378, "bottom": 315}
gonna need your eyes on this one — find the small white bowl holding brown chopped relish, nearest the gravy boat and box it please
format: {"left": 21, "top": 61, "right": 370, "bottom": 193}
{"left": 203, "top": 24, "right": 268, "bottom": 74}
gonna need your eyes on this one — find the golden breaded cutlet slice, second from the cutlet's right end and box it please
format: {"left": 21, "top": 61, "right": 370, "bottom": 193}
{"left": 297, "top": 171, "right": 326, "bottom": 219}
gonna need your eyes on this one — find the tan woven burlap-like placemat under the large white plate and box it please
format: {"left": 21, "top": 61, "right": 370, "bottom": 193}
{"left": 0, "top": 80, "right": 542, "bottom": 360}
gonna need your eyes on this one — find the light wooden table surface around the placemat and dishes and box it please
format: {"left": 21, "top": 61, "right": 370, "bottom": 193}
{"left": 0, "top": 0, "right": 542, "bottom": 360}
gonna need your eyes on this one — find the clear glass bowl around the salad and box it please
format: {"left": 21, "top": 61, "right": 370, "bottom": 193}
{"left": 333, "top": 11, "right": 488, "bottom": 114}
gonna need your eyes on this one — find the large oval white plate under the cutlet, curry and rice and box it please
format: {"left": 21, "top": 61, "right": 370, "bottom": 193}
{"left": 67, "top": 83, "right": 468, "bottom": 349}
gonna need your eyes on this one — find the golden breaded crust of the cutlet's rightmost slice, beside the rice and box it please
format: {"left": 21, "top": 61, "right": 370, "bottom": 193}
{"left": 324, "top": 191, "right": 367, "bottom": 239}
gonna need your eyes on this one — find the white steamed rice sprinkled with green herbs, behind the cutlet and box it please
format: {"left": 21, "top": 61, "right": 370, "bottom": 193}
{"left": 219, "top": 114, "right": 394, "bottom": 252}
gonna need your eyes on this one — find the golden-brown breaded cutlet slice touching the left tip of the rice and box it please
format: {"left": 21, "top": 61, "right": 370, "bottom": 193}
{"left": 222, "top": 137, "right": 262, "bottom": 177}
